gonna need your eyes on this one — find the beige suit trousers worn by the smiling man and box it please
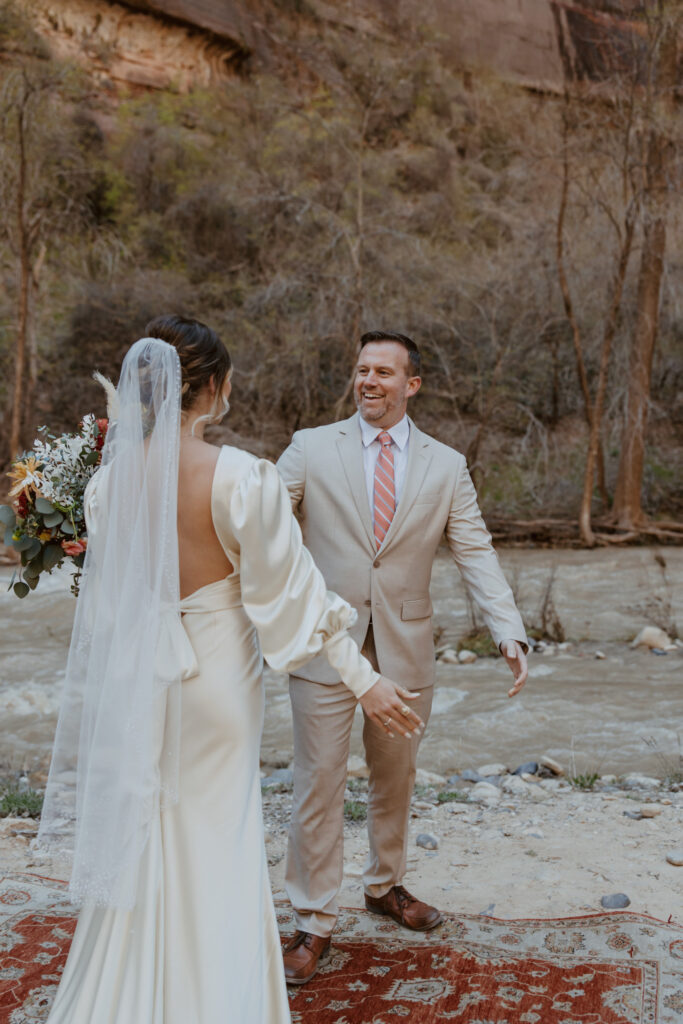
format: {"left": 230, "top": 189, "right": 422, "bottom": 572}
{"left": 285, "top": 628, "right": 433, "bottom": 936}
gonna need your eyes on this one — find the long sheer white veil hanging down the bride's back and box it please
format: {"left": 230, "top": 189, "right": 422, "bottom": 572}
{"left": 36, "top": 338, "right": 181, "bottom": 908}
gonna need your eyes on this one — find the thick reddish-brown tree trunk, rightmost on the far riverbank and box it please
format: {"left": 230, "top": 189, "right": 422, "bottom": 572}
{"left": 613, "top": 13, "right": 677, "bottom": 529}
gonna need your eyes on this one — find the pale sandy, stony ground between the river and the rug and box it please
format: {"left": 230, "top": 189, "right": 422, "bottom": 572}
{"left": 0, "top": 773, "right": 683, "bottom": 923}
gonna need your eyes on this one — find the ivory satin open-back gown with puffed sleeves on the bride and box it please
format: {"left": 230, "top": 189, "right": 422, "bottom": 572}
{"left": 49, "top": 446, "right": 379, "bottom": 1024}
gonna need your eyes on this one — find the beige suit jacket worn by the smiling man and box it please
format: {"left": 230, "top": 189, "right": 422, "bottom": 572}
{"left": 278, "top": 415, "right": 526, "bottom": 689}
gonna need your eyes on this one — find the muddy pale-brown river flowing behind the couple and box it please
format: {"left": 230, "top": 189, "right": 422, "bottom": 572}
{"left": 0, "top": 548, "right": 683, "bottom": 781}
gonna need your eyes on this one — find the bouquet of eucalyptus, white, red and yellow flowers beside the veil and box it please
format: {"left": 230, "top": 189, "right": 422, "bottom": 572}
{"left": 0, "top": 413, "right": 109, "bottom": 597}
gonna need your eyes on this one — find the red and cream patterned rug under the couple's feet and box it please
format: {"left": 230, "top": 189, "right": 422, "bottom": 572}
{"left": 0, "top": 874, "right": 683, "bottom": 1024}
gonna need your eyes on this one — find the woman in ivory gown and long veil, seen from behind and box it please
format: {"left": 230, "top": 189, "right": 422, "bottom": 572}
{"left": 37, "top": 316, "right": 421, "bottom": 1024}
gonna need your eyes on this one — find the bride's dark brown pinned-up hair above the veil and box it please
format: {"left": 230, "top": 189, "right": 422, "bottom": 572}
{"left": 144, "top": 313, "right": 232, "bottom": 409}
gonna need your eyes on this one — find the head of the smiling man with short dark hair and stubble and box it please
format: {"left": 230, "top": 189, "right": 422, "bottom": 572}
{"left": 353, "top": 341, "right": 422, "bottom": 429}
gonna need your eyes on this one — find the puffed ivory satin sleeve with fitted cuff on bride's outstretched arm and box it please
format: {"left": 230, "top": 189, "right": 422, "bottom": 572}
{"left": 230, "top": 460, "right": 381, "bottom": 698}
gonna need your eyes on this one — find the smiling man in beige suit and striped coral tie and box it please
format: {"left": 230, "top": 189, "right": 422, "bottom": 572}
{"left": 278, "top": 331, "right": 527, "bottom": 984}
